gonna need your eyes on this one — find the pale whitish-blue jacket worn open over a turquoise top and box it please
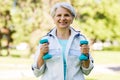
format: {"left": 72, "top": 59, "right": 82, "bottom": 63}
{"left": 32, "top": 27, "right": 93, "bottom": 80}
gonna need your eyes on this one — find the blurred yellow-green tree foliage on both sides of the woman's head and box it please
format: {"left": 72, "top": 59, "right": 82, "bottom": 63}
{"left": 0, "top": 0, "right": 120, "bottom": 53}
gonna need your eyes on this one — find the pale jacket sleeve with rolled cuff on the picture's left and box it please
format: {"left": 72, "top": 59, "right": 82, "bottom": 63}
{"left": 32, "top": 45, "right": 45, "bottom": 77}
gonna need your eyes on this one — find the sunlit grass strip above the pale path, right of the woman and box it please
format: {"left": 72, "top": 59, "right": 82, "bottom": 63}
{"left": 92, "top": 51, "right": 120, "bottom": 64}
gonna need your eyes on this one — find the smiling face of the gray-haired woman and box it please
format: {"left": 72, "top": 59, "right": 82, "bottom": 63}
{"left": 53, "top": 7, "right": 74, "bottom": 28}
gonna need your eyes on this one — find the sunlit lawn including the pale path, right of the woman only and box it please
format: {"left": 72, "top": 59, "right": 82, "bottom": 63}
{"left": 86, "top": 51, "right": 120, "bottom": 80}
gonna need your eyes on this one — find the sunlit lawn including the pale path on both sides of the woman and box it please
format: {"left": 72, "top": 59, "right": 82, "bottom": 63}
{"left": 0, "top": 51, "right": 120, "bottom": 80}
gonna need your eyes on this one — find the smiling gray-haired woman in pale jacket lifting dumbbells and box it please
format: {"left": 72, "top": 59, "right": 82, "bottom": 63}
{"left": 32, "top": 2, "right": 93, "bottom": 80}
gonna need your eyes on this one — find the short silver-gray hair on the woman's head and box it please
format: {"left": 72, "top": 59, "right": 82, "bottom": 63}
{"left": 50, "top": 2, "right": 76, "bottom": 17}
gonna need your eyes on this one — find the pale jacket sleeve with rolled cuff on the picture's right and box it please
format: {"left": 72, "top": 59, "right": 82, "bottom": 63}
{"left": 81, "top": 56, "right": 94, "bottom": 75}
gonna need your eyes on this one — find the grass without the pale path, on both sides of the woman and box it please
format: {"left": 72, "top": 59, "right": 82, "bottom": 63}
{"left": 0, "top": 51, "right": 120, "bottom": 80}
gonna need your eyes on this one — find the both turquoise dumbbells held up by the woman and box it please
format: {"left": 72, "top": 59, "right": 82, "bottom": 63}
{"left": 40, "top": 39, "right": 89, "bottom": 61}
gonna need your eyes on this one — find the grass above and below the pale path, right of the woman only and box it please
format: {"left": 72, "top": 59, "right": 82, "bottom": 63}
{"left": 85, "top": 51, "right": 120, "bottom": 80}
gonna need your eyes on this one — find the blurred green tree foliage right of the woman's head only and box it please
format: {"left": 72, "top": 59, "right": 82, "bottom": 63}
{"left": 73, "top": 0, "right": 120, "bottom": 41}
